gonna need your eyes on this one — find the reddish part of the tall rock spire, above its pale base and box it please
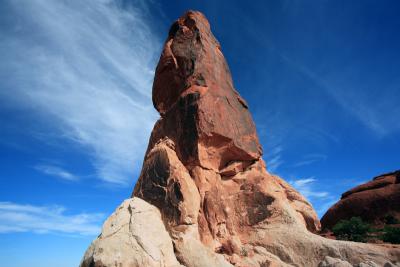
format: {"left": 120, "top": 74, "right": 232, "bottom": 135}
{"left": 133, "top": 12, "right": 320, "bottom": 266}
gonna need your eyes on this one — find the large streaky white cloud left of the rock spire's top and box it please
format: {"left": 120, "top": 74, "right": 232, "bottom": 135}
{"left": 0, "top": 0, "right": 160, "bottom": 184}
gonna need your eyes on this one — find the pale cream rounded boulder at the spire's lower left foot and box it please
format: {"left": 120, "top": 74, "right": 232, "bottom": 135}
{"left": 80, "top": 198, "right": 181, "bottom": 267}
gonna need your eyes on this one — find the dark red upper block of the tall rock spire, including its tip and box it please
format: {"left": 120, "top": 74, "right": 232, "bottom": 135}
{"left": 149, "top": 10, "right": 262, "bottom": 171}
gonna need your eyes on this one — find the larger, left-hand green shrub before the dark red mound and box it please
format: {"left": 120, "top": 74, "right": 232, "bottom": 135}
{"left": 332, "top": 217, "right": 371, "bottom": 242}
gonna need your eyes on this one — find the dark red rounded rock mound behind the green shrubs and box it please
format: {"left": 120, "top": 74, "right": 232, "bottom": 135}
{"left": 321, "top": 170, "right": 400, "bottom": 229}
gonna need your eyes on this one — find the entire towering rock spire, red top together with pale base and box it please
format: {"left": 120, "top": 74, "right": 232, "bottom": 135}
{"left": 81, "top": 11, "right": 400, "bottom": 267}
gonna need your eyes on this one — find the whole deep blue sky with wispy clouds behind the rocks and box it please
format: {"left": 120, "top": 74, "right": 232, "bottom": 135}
{"left": 0, "top": 0, "right": 400, "bottom": 267}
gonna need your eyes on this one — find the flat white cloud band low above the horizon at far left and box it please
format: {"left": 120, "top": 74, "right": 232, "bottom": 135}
{"left": 0, "top": 202, "right": 104, "bottom": 235}
